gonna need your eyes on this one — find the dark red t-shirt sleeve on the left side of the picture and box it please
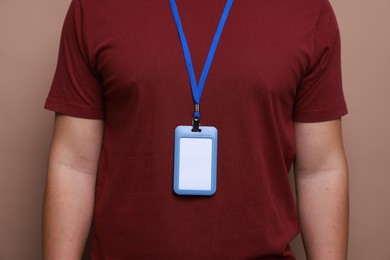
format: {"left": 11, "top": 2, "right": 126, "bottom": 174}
{"left": 45, "top": 0, "right": 104, "bottom": 119}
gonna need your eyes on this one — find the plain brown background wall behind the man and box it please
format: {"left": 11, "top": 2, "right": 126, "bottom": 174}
{"left": 0, "top": 0, "right": 390, "bottom": 260}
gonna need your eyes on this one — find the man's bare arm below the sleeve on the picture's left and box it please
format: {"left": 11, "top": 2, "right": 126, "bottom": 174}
{"left": 43, "top": 115, "right": 103, "bottom": 260}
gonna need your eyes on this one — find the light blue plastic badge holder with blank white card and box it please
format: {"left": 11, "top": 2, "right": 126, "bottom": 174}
{"left": 173, "top": 126, "right": 218, "bottom": 196}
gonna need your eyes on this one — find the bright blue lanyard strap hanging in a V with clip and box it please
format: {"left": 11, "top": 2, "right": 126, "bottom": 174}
{"left": 169, "top": 0, "right": 233, "bottom": 132}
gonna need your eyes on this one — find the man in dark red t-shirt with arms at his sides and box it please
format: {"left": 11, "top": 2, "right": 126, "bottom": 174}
{"left": 44, "top": 0, "right": 348, "bottom": 260}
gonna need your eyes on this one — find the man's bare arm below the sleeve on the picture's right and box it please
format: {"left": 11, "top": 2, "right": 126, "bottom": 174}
{"left": 295, "top": 120, "right": 349, "bottom": 260}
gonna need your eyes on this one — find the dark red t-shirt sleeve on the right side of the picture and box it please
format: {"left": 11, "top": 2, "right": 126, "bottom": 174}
{"left": 293, "top": 0, "right": 348, "bottom": 122}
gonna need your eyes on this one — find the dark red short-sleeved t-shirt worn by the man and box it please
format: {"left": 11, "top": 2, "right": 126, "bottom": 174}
{"left": 45, "top": 0, "right": 347, "bottom": 259}
